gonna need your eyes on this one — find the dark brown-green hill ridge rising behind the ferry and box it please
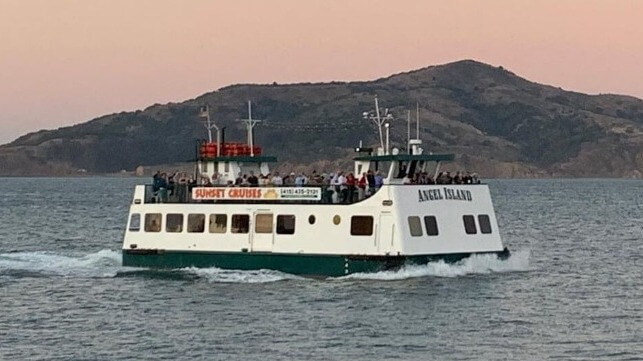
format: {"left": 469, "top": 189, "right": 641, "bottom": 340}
{"left": 0, "top": 60, "right": 643, "bottom": 177}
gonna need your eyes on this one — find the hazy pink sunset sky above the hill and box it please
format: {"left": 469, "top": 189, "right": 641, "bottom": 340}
{"left": 0, "top": 0, "right": 643, "bottom": 143}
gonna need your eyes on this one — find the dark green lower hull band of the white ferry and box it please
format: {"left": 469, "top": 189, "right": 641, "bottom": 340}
{"left": 123, "top": 249, "right": 508, "bottom": 277}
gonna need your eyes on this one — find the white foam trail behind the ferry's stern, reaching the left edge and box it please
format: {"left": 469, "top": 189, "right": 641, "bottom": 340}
{"left": 0, "top": 249, "right": 122, "bottom": 277}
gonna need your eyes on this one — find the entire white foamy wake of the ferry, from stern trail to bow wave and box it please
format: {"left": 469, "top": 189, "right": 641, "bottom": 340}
{"left": 0, "top": 249, "right": 530, "bottom": 283}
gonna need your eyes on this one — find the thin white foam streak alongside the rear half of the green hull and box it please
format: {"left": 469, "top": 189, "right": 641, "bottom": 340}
{"left": 181, "top": 267, "right": 299, "bottom": 283}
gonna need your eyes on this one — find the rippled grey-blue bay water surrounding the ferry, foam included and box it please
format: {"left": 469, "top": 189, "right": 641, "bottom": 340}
{"left": 0, "top": 178, "right": 643, "bottom": 360}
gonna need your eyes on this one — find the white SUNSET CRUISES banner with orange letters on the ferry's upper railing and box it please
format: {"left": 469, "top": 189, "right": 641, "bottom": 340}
{"left": 192, "top": 187, "right": 321, "bottom": 201}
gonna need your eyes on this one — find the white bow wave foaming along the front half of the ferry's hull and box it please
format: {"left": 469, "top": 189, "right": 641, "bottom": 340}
{"left": 340, "top": 250, "right": 530, "bottom": 281}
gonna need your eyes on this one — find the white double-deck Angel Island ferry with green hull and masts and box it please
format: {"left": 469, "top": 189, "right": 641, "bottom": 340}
{"left": 122, "top": 98, "right": 509, "bottom": 277}
